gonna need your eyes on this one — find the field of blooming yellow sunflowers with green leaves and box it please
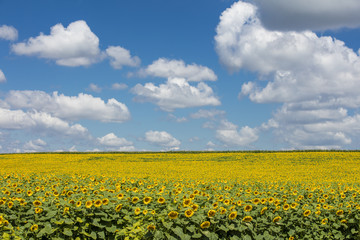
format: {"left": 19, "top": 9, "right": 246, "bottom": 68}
{"left": 0, "top": 151, "right": 360, "bottom": 239}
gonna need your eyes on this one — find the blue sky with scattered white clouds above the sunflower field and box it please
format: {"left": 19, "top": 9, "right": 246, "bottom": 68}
{"left": 0, "top": 0, "right": 360, "bottom": 152}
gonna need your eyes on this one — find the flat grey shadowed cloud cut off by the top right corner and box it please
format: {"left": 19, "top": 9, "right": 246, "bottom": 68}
{"left": 253, "top": 0, "right": 360, "bottom": 30}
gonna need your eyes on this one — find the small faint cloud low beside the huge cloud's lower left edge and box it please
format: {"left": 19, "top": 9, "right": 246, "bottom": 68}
{"left": 216, "top": 120, "right": 259, "bottom": 147}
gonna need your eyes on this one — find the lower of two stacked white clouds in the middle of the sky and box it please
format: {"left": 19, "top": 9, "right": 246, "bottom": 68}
{"left": 132, "top": 78, "right": 220, "bottom": 111}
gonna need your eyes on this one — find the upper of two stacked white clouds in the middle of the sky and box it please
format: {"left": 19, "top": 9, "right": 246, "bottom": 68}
{"left": 139, "top": 58, "right": 217, "bottom": 81}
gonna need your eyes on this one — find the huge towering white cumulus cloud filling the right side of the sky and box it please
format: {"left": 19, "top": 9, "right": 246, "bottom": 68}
{"left": 215, "top": 1, "right": 360, "bottom": 148}
